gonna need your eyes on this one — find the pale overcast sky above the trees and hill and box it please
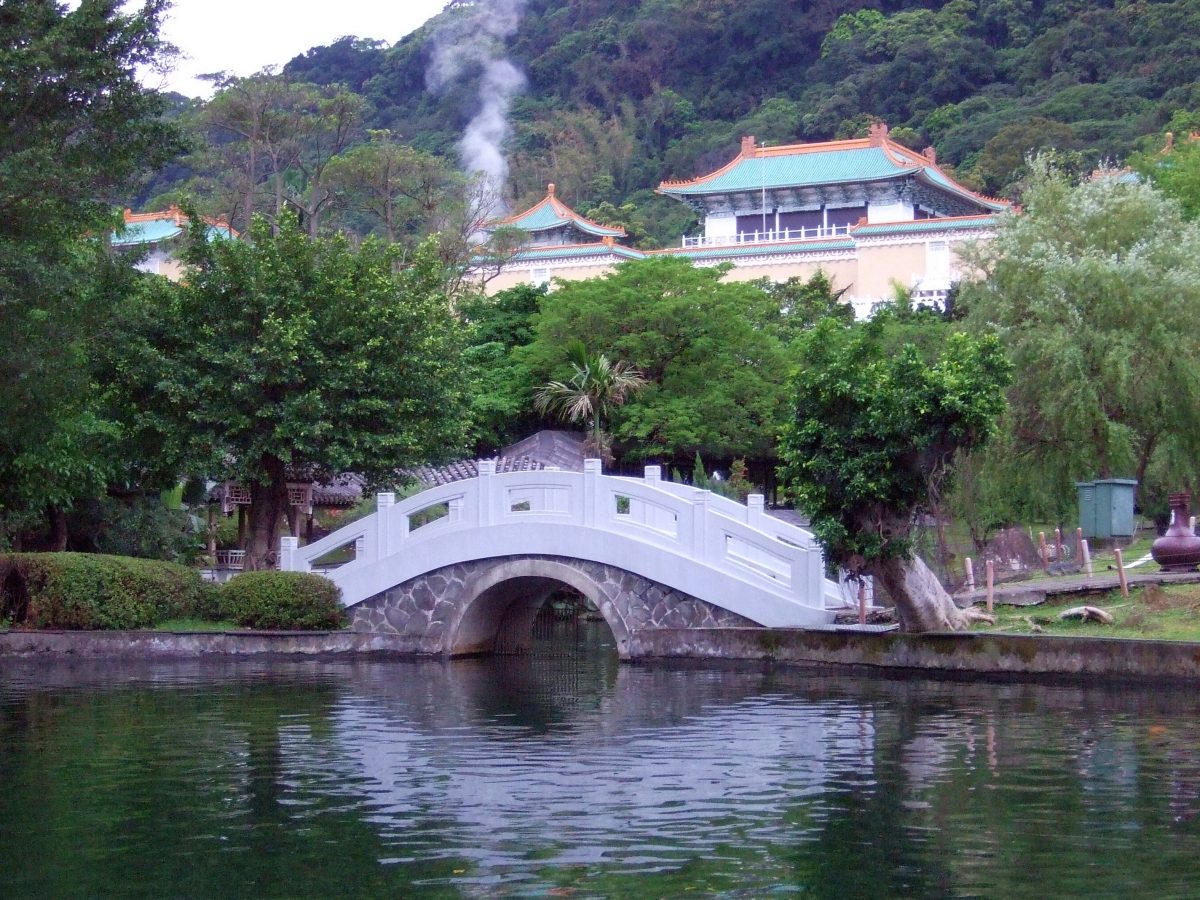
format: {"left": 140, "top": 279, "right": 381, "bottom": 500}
{"left": 82, "top": 0, "right": 446, "bottom": 96}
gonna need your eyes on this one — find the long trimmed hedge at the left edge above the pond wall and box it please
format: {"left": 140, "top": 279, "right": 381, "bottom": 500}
{"left": 0, "top": 553, "right": 218, "bottom": 630}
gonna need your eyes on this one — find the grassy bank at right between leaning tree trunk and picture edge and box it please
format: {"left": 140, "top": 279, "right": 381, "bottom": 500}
{"left": 972, "top": 584, "right": 1200, "bottom": 641}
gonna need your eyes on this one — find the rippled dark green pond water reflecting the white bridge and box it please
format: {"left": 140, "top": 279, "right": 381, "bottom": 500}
{"left": 0, "top": 625, "right": 1200, "bottom": 898}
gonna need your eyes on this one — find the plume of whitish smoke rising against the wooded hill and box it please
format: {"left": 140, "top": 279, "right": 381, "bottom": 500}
{"left": 425, "top": 0, "right": 526, "bottom": 213}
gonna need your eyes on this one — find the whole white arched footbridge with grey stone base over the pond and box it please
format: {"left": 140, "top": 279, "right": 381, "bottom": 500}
{"left": 280, "top": 460, "right": 841, "bottom": 658}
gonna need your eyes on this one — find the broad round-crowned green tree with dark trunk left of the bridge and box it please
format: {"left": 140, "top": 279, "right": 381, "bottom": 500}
{"left": 122, "top": 214, "right": 464, "bottom": 568}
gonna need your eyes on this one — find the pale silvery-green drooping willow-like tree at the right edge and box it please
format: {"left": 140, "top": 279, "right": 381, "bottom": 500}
{"left": 961, "top": 162, "right": 1200, "bottom": 512}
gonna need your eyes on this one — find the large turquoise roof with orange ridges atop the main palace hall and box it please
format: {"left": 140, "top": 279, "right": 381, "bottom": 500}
{"left": 659, "top": 124, "right": 1009, "bottom": 212}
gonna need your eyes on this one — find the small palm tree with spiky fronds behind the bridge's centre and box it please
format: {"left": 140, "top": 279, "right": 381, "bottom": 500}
{"left": 533, "top": 341, "right": 647, "bottom": 461}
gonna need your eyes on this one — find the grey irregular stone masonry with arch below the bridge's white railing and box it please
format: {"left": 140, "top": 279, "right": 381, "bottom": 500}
{"left": 347, "top": 556, "right": 757, "bottom": 658}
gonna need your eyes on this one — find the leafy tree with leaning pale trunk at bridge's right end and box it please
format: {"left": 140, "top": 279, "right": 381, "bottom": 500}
{"left": 780, "top": 311, "right": 1010, "bottom": 631}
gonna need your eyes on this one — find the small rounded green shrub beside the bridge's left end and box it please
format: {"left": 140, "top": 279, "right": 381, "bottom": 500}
{"left": 221, "top": 571, "right": 346, "bottom": 630}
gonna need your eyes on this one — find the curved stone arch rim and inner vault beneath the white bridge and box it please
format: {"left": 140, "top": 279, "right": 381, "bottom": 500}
{"left": 446, "top": 559, "right": 629, "bottom": 658}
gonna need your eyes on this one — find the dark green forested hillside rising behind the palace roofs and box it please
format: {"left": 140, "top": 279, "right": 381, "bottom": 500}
{"left": 272, "top": 0, "right": 1200, "bottom": 236}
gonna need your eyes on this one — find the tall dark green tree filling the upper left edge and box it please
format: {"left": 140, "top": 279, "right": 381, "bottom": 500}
{"left": 0, "top": 0, "right": 181, "bottom": 546}
